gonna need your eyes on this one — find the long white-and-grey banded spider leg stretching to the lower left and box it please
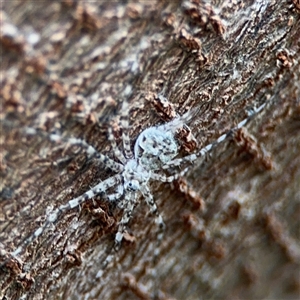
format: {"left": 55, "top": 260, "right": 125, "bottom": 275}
{"left": 12, "top": 175, "right": 121, "bottom": 257}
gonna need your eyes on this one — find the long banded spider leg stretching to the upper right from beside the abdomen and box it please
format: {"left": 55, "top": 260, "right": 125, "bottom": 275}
{"left": 162, "top": 104, "right": 266, "bottom": 170}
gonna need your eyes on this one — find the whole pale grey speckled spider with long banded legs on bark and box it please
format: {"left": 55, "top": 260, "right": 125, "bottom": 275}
{"left": 12, "top": 101, "right": 265, "bottom": 277}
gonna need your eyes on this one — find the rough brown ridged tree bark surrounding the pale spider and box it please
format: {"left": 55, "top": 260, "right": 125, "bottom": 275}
{"left": 0, "top": 0, "right": 300, "bottom": 299}
